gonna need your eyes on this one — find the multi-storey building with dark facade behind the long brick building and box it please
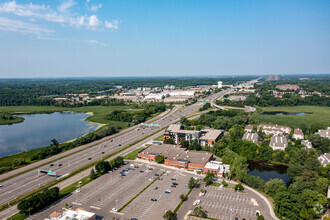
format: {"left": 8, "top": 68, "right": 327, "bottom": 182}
{"left": 163, "top": 124, "right": 224, "bottom": 147}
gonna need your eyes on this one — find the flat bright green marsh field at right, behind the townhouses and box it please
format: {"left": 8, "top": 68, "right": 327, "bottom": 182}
{"left": 253, "top": 106, "right": 330, "bottom": 128}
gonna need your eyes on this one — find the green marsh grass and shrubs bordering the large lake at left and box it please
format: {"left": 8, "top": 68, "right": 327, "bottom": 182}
{"left": 0, "top": 105, "right": 166, "bottom": 175}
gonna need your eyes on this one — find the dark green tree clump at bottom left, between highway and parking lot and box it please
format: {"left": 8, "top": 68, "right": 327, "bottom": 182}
{"left": 17, "top": 187, "right": 60, "bottom": 215}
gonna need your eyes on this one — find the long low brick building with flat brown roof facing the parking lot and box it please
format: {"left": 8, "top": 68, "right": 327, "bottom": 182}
{"left": 138, "top": 144, "right": 213, "bottom": 171}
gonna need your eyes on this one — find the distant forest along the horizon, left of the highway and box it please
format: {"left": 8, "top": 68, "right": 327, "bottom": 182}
{"left": 0, "top": 76, "right": 255, "bottom": 106}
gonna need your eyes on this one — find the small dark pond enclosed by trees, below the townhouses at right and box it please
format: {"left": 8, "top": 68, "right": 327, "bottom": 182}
{"left": 247, "top": 160, "right": 289, "bottom": 184}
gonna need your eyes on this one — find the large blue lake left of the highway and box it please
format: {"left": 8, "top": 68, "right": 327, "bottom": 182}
{"left": 0, "top": 112, "right": 98, "bottom": 157}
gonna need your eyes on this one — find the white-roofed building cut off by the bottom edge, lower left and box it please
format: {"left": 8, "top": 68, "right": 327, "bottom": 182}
{"left": 47, "top": 208, "right": 96, "bottom": 220}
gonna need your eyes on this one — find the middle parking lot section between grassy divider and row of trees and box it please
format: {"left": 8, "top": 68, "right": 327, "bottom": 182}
{"left": 123, "top": 170, "right": 193, "bottom": 219}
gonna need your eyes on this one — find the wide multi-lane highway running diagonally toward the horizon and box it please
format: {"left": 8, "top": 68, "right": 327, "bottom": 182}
{"left": 0, "top": 79, "right": 258, "bottom": 208}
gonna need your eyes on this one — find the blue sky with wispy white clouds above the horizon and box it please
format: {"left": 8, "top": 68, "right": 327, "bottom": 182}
{"left": 0, "top": 0, "right": 330, "bottom": 78}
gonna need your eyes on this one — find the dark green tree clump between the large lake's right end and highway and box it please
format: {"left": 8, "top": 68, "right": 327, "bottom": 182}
{"left": 105, "top": 102, "right": 166, "bottom": 124}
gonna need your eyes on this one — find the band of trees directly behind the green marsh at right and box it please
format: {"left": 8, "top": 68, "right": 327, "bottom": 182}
{"left": 243, "top": 92, "right": 330, "bottom": 107}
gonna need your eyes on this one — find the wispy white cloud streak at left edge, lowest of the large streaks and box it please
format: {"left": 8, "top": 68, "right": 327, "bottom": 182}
{"left": 0, "top": 17, "right": 55, "bottom": 36}
